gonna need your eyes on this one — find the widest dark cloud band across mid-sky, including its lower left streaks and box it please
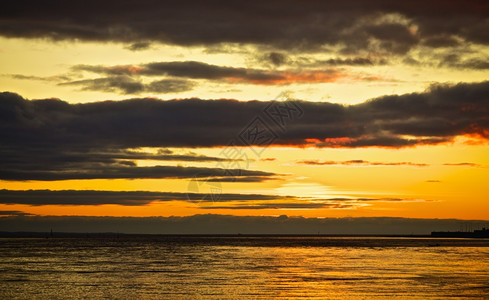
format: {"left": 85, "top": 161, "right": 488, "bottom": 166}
{"left": 0, "top": 82, "right": 489, "bottom": 180}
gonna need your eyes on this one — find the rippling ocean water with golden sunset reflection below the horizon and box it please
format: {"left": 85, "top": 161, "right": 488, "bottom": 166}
{"left": 0, "top": 236, "right": 489, "bottom": 299}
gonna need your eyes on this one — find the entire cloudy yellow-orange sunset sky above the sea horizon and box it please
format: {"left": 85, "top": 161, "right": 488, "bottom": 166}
{"left": 0, "top": 0, "right": 489, "bottom": 233}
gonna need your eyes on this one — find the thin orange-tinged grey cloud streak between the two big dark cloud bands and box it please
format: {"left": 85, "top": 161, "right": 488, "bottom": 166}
{"left": 8, "top": 59, "right": 383, "bottom": 95}
